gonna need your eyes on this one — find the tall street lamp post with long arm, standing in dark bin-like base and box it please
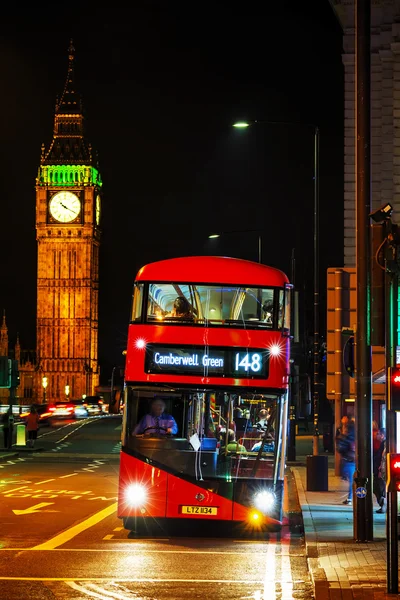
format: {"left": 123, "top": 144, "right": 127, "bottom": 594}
{"left": 233, "top": 120, "right": 328, "bottom": 491}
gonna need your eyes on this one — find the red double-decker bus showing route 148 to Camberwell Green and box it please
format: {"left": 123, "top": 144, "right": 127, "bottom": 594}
{"left": 118, "top": 256, "right": 291, "bottom": 535}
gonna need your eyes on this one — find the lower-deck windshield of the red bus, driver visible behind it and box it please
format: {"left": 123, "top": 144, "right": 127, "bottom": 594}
{"left": 123, "top": 386, "right": 281, "bottom": 481}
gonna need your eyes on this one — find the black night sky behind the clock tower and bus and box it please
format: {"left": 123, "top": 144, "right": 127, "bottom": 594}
{"left": 0, "top": 0, "right": 343, "bottom": 382}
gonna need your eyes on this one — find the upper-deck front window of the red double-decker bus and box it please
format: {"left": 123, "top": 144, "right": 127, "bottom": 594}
{"left": 132, "top": 283, "right": 289, "bottom": 329}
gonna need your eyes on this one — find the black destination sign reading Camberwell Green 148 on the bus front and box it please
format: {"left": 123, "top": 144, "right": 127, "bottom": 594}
{"left": 145, "top": 344, "right": 269, "bottom": 378}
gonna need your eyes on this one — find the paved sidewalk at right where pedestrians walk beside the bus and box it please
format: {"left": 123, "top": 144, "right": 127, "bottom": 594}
{"left": 290, "top": 455, "right": 400, "bottom": 600}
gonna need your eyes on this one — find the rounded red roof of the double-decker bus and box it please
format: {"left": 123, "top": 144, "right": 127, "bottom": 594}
{"left": 136, "top": 256, "right": 289, "bottom": 287}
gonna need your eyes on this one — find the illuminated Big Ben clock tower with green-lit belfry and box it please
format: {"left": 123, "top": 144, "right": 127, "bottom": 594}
{"left": 36, "top": 41, "right": 102, "bottom": 401}
